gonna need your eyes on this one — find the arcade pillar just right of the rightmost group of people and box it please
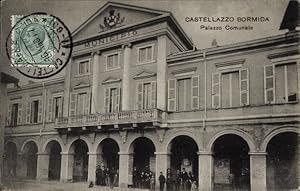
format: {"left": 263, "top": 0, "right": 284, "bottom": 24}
{"left": 198, "top": 151, "right": 214, "bottom": 191}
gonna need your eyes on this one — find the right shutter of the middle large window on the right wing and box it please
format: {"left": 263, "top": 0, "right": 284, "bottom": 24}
{"left": 239, "top": 68, "right": 249, "bottom": 106}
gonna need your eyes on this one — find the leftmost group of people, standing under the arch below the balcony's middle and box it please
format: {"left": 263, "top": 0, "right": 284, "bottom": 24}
{"left": 96, "top": 164, "right": 119, "bottom": 188}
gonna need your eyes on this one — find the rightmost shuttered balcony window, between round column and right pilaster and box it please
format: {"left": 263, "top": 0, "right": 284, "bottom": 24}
{"left": 136, "top": 81, "right": 156, "bottom": 109}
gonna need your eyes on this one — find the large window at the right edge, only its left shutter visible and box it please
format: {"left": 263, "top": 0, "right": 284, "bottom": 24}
{"left": 264, "top": 63, "right": 298, "bottom": 104}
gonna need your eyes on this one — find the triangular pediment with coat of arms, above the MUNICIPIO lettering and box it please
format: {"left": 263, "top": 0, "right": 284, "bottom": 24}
{"left": 72, "top": 2, "right": 167, "bottom": 40}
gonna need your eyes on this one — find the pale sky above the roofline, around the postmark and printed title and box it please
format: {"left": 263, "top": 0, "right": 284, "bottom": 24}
{"left": 0, "top": 0, "right": 289, "bottom": 85}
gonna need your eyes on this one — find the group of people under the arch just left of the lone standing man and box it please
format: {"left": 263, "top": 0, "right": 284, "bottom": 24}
{"left": 132, "top": 166, "right": 155, "bottom": 190}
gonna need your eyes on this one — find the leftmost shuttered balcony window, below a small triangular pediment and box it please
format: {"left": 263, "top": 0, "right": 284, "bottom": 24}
{"left": 69, "top": 92, "right": 91, "bottom": 116}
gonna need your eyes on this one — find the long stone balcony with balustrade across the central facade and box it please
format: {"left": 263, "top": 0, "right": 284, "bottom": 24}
{"left": 56, "top": 109, "right": 162, "bottom": 131}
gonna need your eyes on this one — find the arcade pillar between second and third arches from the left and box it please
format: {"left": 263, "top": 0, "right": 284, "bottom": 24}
{"left": 36, "top": 153, "right": 49, "bottom": 180}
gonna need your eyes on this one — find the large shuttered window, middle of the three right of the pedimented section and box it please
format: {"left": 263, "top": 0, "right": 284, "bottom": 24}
{"left": 212, "top": 69, "right": 249, "bottom": 108}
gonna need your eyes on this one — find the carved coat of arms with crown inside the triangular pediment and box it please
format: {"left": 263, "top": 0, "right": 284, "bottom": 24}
{"left": 99, "top": 10, "right": 125, "bottom": 32}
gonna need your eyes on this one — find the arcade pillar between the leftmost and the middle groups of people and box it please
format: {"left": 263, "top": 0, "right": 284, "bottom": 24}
{"left": 119, "top": 152, "right": 133, "bottom": 188}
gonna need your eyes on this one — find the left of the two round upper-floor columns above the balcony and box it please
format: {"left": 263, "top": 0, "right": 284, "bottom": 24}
{"left": 91, "top": 51, "right": 100, "bottom": 113}
